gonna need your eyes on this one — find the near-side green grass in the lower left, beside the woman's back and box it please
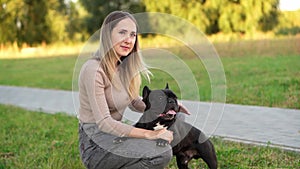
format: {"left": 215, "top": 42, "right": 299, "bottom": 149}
{"left": 0, "top": 105, "right": 83, "bottom": 169}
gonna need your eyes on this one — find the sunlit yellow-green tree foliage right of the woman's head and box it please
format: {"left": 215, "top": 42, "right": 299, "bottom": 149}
{"left": 143, "top": 0, "right": 279, "bottom": 34}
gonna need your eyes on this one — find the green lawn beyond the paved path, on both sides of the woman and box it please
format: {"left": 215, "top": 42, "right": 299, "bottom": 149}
{"left": 0, "top": 38, "right": 300, "bottom": 109}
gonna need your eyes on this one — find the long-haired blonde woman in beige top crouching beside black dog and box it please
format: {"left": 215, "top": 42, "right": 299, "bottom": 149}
{"left": 78, "top": 11, "right": 190, "bottom": 169}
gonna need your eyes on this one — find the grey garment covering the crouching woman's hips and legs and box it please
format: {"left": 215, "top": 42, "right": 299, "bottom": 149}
{"left": 79, "top": 124, "right": 172, "bottom": 169}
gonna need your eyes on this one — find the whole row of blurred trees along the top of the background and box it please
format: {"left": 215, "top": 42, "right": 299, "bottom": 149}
{"left": 0, "top": 0, "right": 299, "bottom": 46}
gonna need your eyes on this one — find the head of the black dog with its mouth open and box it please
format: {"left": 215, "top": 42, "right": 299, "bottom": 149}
{"left": 143, "top": 84, "right": 179, "bottom": 120}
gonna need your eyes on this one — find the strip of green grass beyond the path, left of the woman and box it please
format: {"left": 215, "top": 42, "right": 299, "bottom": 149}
{"left": 0, "top": 56, "right": 76, "bottom": 90}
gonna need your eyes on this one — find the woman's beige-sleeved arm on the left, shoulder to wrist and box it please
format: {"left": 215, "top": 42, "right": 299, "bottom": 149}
{"left": 80, "top": 62, "right": 134, "bottom": 137}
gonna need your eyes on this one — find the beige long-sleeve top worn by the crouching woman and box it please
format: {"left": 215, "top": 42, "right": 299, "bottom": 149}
{"left": 78, "top": 59, "right": 145, "bottom": 136}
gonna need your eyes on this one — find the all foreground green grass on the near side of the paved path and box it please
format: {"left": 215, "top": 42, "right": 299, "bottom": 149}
{"left": 0, "top": 105, "right": 300, "bottom": 169}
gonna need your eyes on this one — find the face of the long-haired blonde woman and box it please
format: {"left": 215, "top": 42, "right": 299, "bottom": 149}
{"left": 111, "top": 18, "right": 137, "bottom": 57}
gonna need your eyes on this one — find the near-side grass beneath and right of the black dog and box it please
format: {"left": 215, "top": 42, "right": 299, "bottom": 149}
{"left": 169, "top": 138, "right": 300, "bottom": 169}
